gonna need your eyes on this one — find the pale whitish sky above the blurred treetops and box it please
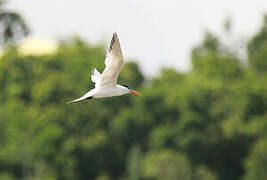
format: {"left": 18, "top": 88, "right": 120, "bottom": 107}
{"left": 6, "top": 0, "right": 267, "bottom": 75}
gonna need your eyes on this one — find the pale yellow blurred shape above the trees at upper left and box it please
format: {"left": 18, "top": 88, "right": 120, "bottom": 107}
{"left": 18, "top": 36, "right": 58, "bottom": 56}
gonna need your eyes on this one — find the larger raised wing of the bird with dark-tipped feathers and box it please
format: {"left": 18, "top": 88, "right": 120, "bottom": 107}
{"left": 96, "top": 33, "right": 124, "bottom": 87}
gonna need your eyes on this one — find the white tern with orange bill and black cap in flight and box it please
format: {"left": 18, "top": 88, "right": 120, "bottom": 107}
{"left": 69, "top": 33, "right": 140, "bottom": 103}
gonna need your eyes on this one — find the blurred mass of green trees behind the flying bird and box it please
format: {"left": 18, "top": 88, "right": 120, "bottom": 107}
{"left": 0, "top": 9, "right": 267, "bottom": 180}
